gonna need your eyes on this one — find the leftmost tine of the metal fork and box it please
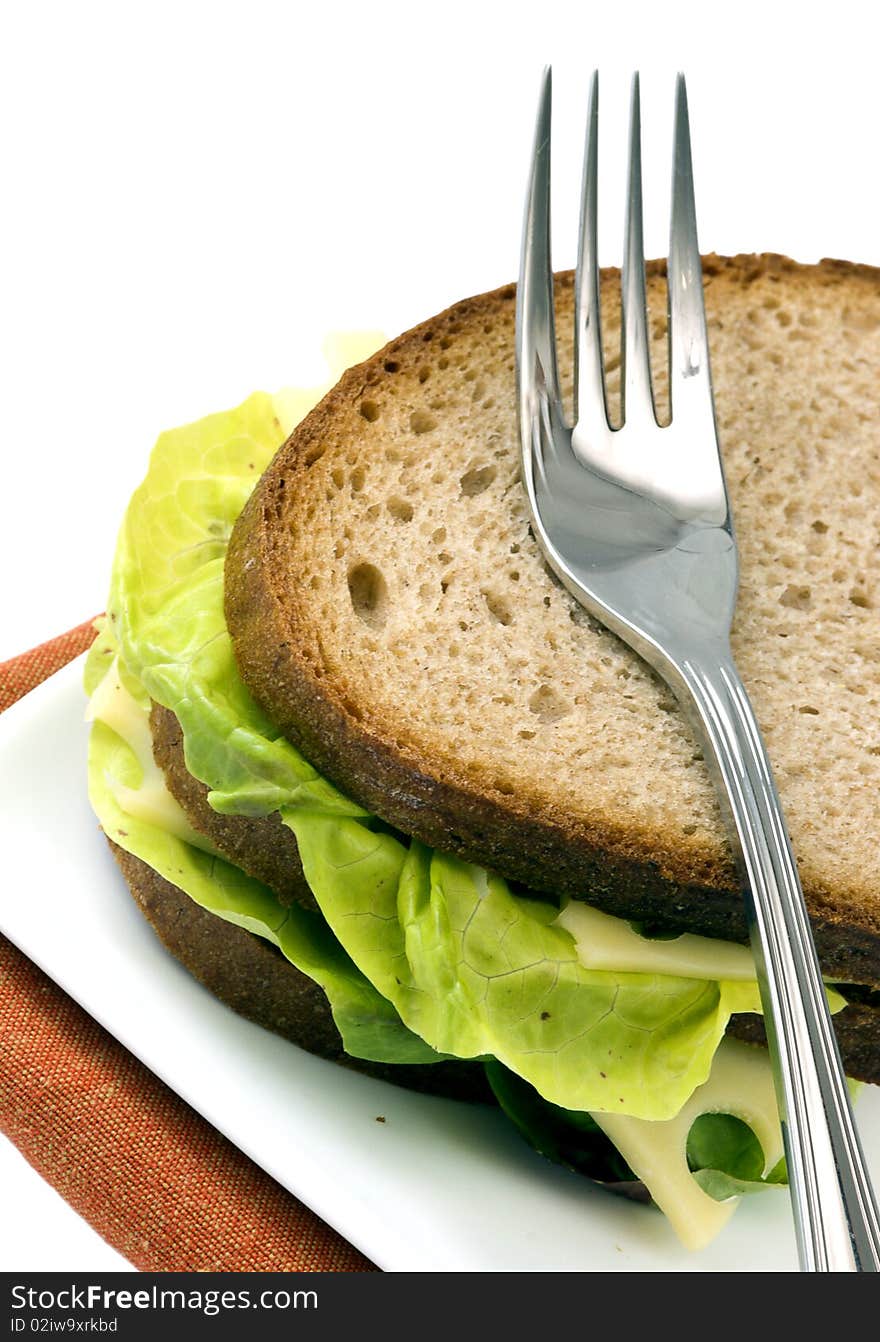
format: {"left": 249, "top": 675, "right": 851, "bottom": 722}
{"left": 516, "top": 66, "right": 559, "bottom": 450}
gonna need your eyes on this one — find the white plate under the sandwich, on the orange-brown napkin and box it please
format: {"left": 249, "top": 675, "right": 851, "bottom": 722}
{"left": 0, "top": 659, "right": 880, "bottom": 1272}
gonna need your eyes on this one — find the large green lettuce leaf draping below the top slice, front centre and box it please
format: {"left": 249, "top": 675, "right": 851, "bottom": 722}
{"left": 282, "top": 808, "right": 761, "bottom": 1118}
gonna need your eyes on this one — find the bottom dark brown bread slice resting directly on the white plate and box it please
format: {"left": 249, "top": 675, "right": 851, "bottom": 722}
{"left": 107, "top": 840, "right": 491, "bottom": 1102}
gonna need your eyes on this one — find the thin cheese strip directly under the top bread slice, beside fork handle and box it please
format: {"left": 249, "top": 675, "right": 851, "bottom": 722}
{"left": 555, "top": 899, "right": 755, "bottom": 982}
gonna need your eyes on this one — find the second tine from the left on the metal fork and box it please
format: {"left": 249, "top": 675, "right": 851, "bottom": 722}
{"left": 574, "top": 70, "right": 609, "bottom": 444}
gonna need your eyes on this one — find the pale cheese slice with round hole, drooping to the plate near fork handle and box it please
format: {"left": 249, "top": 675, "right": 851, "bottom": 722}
{"left": 593, "top": 1039, "right": 783, "bottom": 1249}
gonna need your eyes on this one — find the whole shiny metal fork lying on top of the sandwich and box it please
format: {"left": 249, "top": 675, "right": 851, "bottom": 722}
{"left": 516, "top": 70, "right": 880, "bottom": 1271}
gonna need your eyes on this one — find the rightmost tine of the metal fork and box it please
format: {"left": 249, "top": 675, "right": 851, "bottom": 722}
{"left": 668, "top": 74, "right": 712, "bottom": 420}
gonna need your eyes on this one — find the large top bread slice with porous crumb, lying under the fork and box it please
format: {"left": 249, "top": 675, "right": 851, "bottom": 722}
{"left": 225, "top": 256, "right": 880, "bottom": 985}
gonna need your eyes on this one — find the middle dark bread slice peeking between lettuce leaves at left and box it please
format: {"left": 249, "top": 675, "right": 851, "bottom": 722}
{"left": 150, "top": 703, "right": 318, "bottom": 909}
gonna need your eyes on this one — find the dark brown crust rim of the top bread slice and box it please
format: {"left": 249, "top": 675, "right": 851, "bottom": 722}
{"left": 225, "top": 256, "right": 880, "bottom": 985}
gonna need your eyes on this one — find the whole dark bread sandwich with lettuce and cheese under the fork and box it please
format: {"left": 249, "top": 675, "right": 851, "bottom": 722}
{"left": 86, "top": 256, "right": 880, "bottom": 1248}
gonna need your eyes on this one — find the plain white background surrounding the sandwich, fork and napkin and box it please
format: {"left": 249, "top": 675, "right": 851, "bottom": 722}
{"left": 0, "top": 0, "right": 880, "bottom": 1271}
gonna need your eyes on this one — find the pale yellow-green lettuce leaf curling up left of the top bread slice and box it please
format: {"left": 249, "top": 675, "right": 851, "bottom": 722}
{"left": 107, "top": 393, "right": 364, "bottom": 816}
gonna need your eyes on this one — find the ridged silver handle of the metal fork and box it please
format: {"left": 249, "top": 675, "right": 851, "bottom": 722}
{"left": 679, "top": 648, "right": 880, "bottom": 1272}
